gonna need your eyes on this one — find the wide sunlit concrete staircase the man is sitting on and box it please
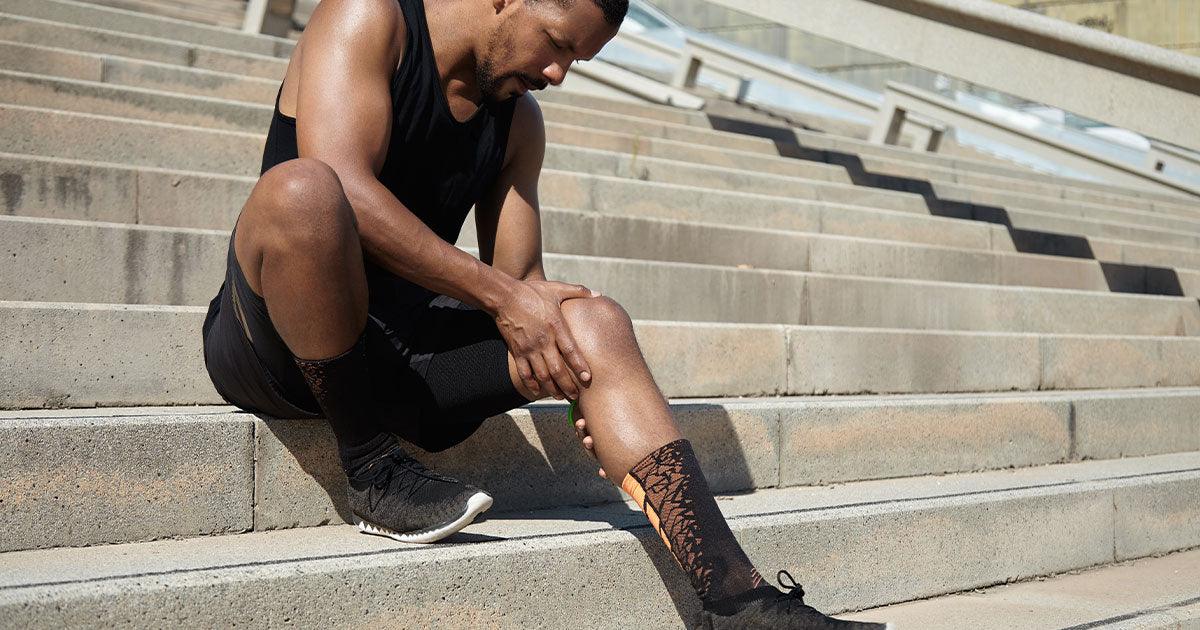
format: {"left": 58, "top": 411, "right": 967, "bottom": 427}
{"left": 0, "top": 0, "right": 1200, "bottom": 628}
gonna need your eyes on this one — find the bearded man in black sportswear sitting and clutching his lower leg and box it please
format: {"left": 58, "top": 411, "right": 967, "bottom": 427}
{"left": 204, "top": 0, "right": 888, "bottom": 628}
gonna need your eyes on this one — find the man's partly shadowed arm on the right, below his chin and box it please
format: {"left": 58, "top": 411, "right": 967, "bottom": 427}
{"left": 475, "top": 94, "right": 546, "bottom": 280}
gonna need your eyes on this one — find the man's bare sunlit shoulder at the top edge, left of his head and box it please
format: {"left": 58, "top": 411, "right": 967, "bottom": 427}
{"left": 305, "top": 0, "right": 408, "bottom": 62}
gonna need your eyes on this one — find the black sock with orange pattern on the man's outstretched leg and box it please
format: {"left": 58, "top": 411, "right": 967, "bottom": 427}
{"left": 620, "top": 439, "right": 763, "bottom": 602}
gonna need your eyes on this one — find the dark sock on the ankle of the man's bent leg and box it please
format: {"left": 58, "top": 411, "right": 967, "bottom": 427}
{"left": 293, "top": 331, "right": 396, "bottom": 476}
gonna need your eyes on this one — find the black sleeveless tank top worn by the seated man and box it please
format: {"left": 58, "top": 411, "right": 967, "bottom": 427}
{"left": 262, "top": 0, "right": 516, "bottom": 332}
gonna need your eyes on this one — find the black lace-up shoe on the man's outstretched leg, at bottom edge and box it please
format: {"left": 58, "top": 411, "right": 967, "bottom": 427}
{"left": 698, "top": 571, "right": 892, "bottom": 630}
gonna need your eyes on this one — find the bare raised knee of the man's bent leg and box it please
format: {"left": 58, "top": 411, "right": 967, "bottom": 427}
{"left": 253, "top": 157, "right": 358, "bottom": 252}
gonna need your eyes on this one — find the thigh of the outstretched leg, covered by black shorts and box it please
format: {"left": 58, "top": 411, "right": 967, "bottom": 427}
{"left": 376, "top": 295, "right": 529, "bottom": 451}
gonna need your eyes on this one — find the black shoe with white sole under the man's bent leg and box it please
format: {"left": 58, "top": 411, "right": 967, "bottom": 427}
{"left": 348, "top": 446, "right": 492, "bottom": 542}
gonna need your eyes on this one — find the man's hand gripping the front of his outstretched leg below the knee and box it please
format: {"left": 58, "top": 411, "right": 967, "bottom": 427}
{"left": 496, "top": 280, "right": 600, "bottom": 400}
